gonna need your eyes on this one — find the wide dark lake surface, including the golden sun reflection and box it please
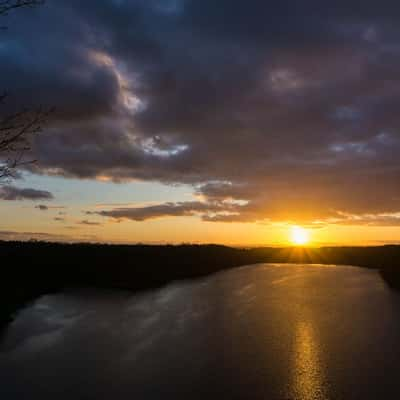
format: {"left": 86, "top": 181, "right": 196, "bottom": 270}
{"left": 0, "top": 264, "right": 400, "bottom": 400}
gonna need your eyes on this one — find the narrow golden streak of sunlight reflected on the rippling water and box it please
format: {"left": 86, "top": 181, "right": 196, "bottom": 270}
{"left": 292, "top": 321, "right": 327, "bottom": 400}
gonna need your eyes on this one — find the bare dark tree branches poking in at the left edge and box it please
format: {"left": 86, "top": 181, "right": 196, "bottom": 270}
{"left": 0, "top": 0, "right": 49, "bottom": 183}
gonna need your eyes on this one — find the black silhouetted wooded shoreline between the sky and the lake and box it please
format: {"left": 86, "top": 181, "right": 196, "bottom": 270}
{"left": 0, "top": 242, "right": 400, "bottom": 325}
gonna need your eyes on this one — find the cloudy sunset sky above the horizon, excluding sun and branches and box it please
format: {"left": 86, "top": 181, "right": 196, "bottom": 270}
{"left": 0, "top": 0, "right": 400, "bottom": 245}
